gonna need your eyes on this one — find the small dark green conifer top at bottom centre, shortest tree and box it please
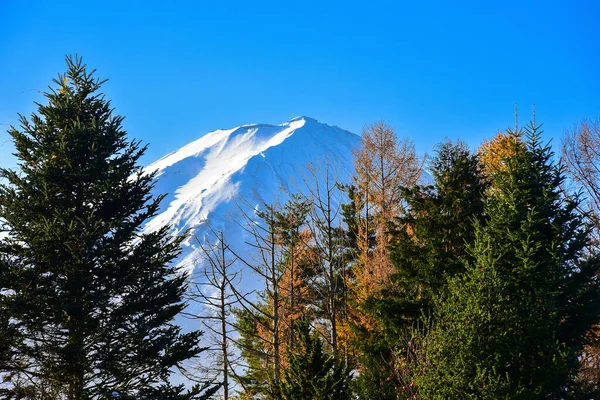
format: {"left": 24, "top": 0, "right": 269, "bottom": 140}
{"left": 280, "top": 321, "right": 350, "bottom": 400}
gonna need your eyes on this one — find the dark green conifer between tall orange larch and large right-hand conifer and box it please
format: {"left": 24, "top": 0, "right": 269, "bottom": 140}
{"left": 391, "top": 141, "right": 487, "bottom": 310}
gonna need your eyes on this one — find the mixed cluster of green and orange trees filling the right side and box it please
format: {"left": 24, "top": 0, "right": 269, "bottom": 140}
{"left": 195, "top": 114, "right": 600, "bottom": 399}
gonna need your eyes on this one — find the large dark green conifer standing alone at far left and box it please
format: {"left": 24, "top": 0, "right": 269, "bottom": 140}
{"left": 0, "top": 57, "right": 214, "bottom": 400}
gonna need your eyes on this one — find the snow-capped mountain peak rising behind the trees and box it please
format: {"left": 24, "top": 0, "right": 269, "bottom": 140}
{"left": 145, "top": 117, "right": 360, "bottom": 276}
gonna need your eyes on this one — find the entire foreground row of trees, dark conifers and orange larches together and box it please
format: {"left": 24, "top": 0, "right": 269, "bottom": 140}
{"left": 0, "top": 57, "right": 600, "bottom": 400}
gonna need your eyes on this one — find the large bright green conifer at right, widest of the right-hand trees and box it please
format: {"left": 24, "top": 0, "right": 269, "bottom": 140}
{"left": 419, "top": 125, "right": 600, "bottom": 399}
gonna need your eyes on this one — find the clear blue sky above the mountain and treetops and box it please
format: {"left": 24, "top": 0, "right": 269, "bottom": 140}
{"left": 0, "top": 0, "right": 600, "bottom": 166}
